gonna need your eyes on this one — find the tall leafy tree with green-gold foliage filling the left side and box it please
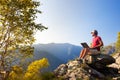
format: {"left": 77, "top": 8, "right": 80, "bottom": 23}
{"left": 0, "top": 0, "right": 47, "bottom": 78}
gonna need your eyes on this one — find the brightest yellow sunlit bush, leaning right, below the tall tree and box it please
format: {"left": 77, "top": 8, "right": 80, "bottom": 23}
{"left": 24, "top": 58, "right": 49, "bottom": 80}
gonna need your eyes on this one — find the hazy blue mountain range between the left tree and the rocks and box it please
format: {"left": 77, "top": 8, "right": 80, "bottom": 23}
{"left": 33, "top": 43, "right": 82, "bottom": 71}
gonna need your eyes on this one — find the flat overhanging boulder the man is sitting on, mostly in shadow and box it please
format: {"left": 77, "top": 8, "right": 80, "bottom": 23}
{"left": 85, "top": 54, "right": 115, "bottom": 69}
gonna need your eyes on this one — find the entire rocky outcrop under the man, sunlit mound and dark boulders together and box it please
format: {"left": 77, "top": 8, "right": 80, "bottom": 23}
{"left": 54, "top": 55, "right": 120, "bottom": 80}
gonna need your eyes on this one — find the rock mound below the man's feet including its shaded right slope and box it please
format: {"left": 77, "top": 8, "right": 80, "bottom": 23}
{"left": 54, "top": 61, "right": 104, "bottom": 80}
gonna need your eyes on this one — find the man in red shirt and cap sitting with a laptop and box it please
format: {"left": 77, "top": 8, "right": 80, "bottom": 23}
{"left": 79, "top": 30, "right": 103, "bottom": 59}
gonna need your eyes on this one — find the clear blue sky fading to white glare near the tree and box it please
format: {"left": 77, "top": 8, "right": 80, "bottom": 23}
{"left": 35, "top": 0, "right": 120, "bottom": 45}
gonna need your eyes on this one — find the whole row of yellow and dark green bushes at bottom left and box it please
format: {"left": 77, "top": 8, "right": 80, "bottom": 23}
{"left": 8, "top": 58, "right": 49, "bottom": 80}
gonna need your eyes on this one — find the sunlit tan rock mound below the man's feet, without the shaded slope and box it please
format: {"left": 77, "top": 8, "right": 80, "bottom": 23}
{"left": 54, "top": 60, "right": 95, "bottom": 80}
